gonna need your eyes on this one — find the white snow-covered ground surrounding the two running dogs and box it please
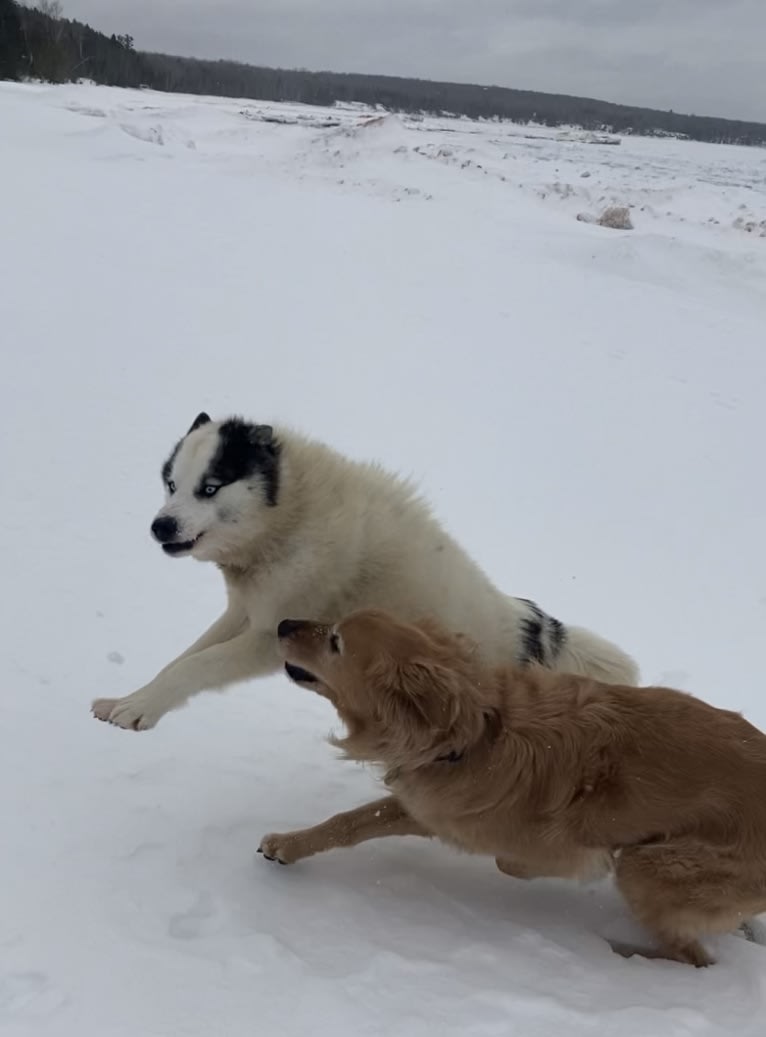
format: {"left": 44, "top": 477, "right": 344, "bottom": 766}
{"left": 0, "top": 83, "right": 766, "bottom": 1037}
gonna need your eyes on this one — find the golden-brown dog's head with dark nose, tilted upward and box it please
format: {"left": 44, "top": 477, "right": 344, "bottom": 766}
{"left": 278, "top": 610, "right": 485, "bottom": 766}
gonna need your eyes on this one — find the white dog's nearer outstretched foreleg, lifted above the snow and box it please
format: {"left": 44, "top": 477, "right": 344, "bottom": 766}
{"left": 91, "top": 628, "right": 280, "bottom": 731}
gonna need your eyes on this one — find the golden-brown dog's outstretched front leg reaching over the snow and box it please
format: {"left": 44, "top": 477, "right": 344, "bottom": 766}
{"left": 258, "top": 795, "right": 424, "bottom": 864}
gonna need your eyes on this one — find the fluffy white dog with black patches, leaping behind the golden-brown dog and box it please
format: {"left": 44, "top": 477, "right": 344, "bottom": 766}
{"left": 92, "top": 415, "right": 637, "bottom": 730}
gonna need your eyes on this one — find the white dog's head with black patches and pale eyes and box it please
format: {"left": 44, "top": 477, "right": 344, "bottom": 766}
{"left": 151, "top": 414, "right": 280, "bottom": 563}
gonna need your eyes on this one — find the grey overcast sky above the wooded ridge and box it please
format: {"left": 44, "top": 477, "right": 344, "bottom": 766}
{"left": 62, "top": 0, "right": 766, "bottom": 122}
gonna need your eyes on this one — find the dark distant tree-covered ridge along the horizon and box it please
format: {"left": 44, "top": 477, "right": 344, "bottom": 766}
{"left": 0, "top": 0, "right": 766, "bottom": 146}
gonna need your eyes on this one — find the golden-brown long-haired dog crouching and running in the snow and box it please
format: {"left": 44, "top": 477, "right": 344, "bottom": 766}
{"left": 260, "top": 611, "right": 766, "bottom": 965}
